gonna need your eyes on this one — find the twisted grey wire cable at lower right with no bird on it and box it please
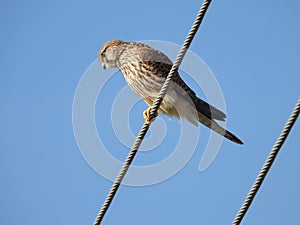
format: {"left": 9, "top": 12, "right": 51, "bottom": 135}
{"left": 232, "top": 99, "right": 300, "bottom": 225}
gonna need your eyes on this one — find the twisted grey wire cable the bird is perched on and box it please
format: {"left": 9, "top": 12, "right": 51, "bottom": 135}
{"left": 94, "top": 0, "right": 211, "bottom": 225}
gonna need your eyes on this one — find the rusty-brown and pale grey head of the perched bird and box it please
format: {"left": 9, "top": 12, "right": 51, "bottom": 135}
{"left": 98, "top": 40, "right": 126, "bottom": 69}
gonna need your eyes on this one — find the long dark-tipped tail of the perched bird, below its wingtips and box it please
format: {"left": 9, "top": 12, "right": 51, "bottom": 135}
{"left": 198, "top": 112, "right": 243, "bottom": 144}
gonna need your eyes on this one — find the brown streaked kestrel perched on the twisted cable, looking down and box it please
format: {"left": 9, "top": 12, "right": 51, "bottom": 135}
{"left": 98, "top": 40, "right": 243, "bottom": 144}
